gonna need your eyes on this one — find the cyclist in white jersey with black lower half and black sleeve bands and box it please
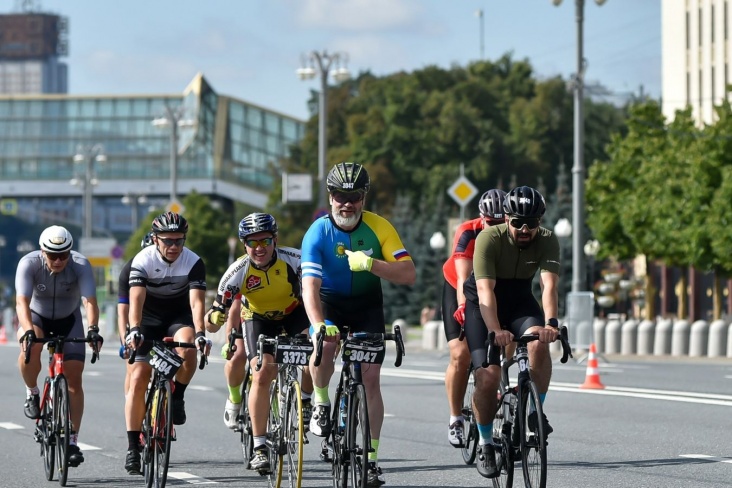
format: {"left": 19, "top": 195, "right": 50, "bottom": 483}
{"left": 125, "top": 212, "right": 210, "bottom": 474}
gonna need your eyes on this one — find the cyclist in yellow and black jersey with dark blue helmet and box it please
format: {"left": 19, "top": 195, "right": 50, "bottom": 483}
{"left": 206, "top": 213, "right": 313, "bottom": 472}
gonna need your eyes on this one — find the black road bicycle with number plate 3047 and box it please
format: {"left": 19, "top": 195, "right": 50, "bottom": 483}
{"left": 315, "top": 325, "right": 405, "bottom": 488}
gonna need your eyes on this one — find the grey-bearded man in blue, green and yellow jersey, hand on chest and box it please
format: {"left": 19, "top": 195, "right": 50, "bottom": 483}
{"left": 302, "top": 163, "right": 417, "bottom": 486}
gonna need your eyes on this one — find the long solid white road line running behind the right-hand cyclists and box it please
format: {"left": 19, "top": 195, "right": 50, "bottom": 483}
{"left": 381, "top": 368, "right": 732, "bottom": 407}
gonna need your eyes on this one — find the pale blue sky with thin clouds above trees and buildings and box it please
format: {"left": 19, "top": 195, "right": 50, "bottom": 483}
{"left": 28, "top": 0, "right": 661, "bottom": 119}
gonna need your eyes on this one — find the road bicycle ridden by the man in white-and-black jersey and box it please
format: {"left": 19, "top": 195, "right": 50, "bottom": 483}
{"left": 129, "top": 337, "right": 208, "bottom": 488}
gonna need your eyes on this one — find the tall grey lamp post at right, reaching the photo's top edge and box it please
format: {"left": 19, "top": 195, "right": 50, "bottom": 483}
{"left": 552, "top": 0, "right": 605, "bottom": 292}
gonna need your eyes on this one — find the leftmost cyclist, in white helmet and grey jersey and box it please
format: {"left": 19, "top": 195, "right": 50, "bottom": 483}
{"left": 15, "top": 225, "right": 102, "bottom": 467}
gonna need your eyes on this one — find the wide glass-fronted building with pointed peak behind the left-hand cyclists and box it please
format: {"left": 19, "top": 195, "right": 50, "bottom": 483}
{"left": 0, "top": 74, "right": 304, "bottom": 236}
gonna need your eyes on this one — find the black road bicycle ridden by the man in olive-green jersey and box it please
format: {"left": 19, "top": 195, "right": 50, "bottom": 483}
{"left": 482, "top": 326, "right": 572, "bottom": 488}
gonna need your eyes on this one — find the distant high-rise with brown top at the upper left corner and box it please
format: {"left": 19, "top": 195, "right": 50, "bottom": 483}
{"left": 0, "top": 12, "right": 68, "bottom": 95}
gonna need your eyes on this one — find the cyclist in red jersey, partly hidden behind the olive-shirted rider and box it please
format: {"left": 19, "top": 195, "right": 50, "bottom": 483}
{"left": 442, "top": 189, "right": 506, "bottom": 447}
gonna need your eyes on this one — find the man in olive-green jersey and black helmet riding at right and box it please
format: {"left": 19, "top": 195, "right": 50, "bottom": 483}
{"left": 464, "top": 186, "right": 560, "bottom": 478}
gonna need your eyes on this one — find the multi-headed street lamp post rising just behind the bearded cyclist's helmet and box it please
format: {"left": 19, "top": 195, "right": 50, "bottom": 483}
{"left": 295, "top": 51, "right": 351, "bottom": 208}
